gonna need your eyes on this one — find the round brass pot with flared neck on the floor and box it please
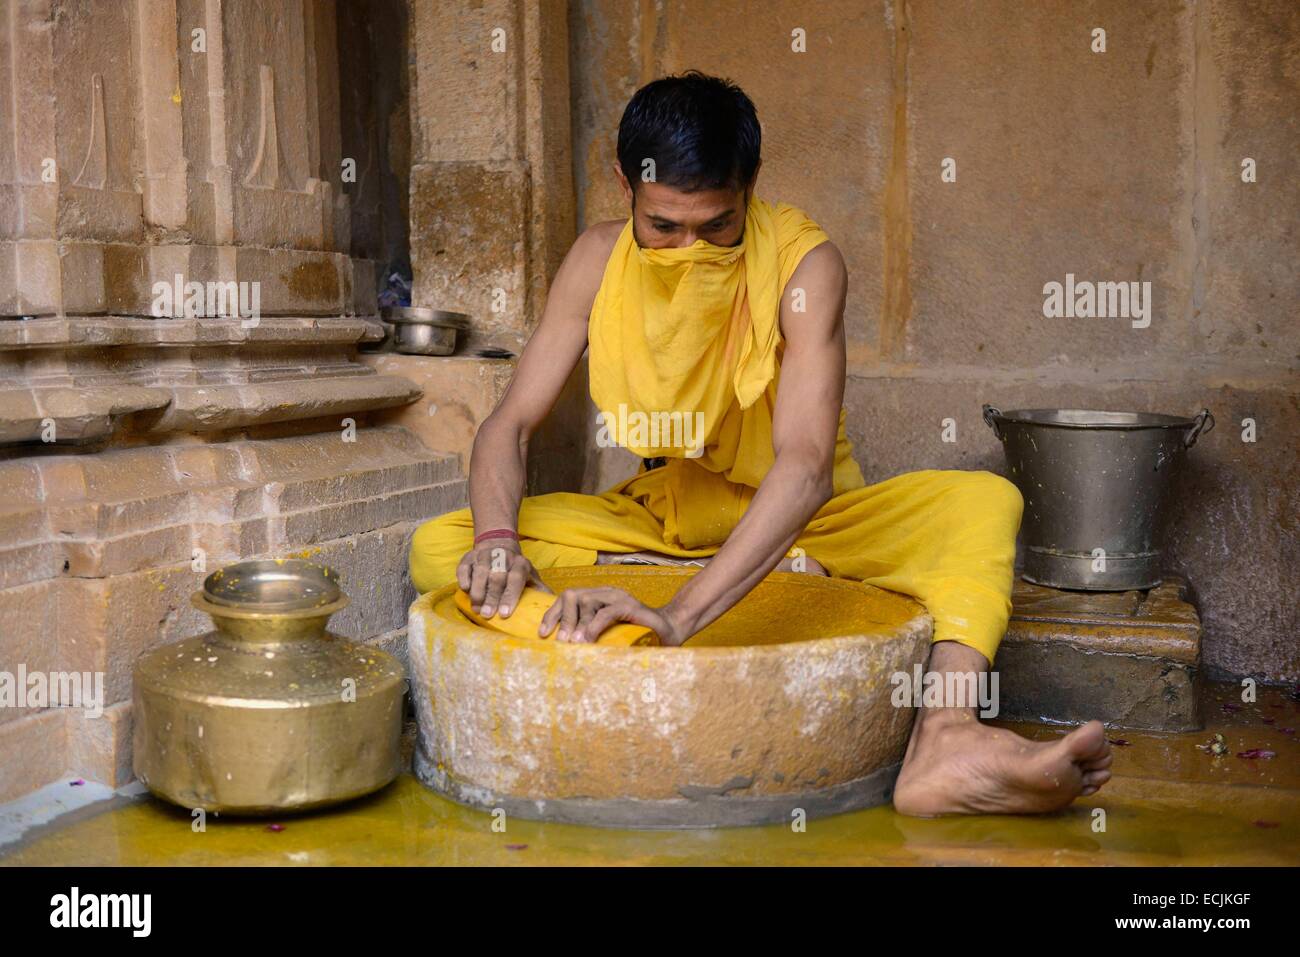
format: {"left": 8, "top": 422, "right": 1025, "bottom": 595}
{"left": 134, "top": 559, "right": 406, "bottom": 814}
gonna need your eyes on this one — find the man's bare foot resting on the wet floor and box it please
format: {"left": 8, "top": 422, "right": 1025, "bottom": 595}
{"left": 893, "top": 709, "right": 1112, "bottom": 817}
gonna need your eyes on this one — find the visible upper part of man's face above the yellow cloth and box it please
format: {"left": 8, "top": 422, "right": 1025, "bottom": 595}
{"left": 619, "top": 170, "right": 749, "bottom": 250}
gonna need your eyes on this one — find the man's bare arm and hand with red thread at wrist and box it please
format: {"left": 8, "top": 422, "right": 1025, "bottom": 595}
{"left": 456, "top": 222, "right": 623, "bottom": 618}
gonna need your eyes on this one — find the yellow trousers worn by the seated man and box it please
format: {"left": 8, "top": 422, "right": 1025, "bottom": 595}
{"left": 411, "top": 468, "right": 1023, "bottom": 662}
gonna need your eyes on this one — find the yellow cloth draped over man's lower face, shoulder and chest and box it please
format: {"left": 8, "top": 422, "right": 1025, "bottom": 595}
{"left": 588, "top": 199, "right": 862, "bottom": 514}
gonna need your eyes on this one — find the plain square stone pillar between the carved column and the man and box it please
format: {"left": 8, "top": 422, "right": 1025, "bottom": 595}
{"left": 411, "top": 0, "right": 573, "bottom": 352}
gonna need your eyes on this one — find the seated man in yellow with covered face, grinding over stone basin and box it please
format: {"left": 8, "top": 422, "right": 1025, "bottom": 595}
{"left": 411, "top": 73, "right": 1110, "bottom": 815}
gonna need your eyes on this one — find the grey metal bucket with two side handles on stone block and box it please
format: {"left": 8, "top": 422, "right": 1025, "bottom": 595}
{"left": 984, "top": 406, "right": 1214, "bottom": 592}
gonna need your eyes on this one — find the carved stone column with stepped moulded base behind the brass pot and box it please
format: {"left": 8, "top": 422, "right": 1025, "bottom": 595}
{"left": 0, "top": 0, "right": 465, "bottom": 801}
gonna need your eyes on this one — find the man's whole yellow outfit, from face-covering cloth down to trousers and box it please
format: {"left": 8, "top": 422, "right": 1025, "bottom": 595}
{"left": 411, "top": 198, "right": 1022, "bottom": 661}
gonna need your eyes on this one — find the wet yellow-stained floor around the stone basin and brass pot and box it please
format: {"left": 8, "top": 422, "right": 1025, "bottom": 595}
{"left": 0, "top": 685, "right": 1300, "bottom": 866}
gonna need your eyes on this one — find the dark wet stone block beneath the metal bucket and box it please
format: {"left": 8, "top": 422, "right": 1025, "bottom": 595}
{"left": 995, "top": 576, "right": 1201, "bottom": 731}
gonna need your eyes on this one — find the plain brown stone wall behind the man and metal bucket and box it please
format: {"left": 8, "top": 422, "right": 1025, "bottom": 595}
{"left": 569, "top": 0, "right": 1300, "bottom": 681}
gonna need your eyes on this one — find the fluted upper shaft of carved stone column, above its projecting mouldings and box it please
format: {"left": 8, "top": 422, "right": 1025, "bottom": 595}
{"left": 0, "top": 0, "right": 374, "bottom": 316}
